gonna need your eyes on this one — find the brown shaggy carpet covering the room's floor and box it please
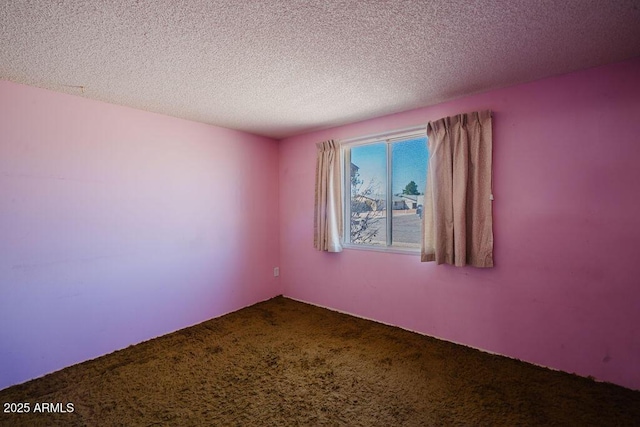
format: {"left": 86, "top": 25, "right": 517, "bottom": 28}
{"left": 0, "top": 297, "right": 640, "bottom": 426}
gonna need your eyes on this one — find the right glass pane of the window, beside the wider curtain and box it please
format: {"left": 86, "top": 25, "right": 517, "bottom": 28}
{"left": 391, "top": 137, "right": 428, "bottom": 249}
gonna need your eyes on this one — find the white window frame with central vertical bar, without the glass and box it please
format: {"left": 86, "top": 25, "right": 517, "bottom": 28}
{"left": 340, "top": 125, "right": 428, "bottom": 255}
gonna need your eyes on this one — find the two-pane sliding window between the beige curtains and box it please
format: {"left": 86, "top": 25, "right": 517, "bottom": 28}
{"left": 343, "top": 128, "right": 428, "bottom": 252}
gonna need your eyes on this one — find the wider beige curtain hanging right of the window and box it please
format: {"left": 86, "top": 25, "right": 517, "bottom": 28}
{"left": 421, "top": 111, "right": 493, "bottom": 267}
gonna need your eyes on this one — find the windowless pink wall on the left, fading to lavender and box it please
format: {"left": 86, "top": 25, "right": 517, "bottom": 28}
{"left": 0, "top": 81, "right": 282, "bottom": 389}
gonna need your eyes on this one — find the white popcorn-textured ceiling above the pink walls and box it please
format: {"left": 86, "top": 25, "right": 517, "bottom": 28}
{"left": 0, "top": 0, "right": 640, "bottom": 138}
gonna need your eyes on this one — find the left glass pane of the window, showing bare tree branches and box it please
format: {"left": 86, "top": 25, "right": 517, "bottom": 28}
{"left": 350, "top": 142, "right": 387, "bottom": 246}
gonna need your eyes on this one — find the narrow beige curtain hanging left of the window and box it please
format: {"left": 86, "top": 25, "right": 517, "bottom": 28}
{"left": 313, "top": 140, "right": 342, "bottom": 252}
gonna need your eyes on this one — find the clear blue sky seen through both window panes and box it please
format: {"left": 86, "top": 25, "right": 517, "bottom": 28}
{"left": 351, "top": 137, "right": 428, "bottom": 194}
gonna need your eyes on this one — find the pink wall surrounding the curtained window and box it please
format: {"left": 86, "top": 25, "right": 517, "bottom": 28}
{"left": 280, "top": 58, "right": 640, "bottom": 389}
